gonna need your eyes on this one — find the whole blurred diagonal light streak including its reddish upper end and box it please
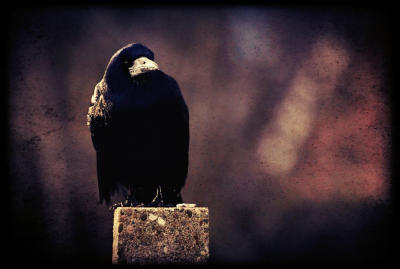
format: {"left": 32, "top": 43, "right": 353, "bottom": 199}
{"left": 258, "top": 38, "right": 348, "bottom": 176}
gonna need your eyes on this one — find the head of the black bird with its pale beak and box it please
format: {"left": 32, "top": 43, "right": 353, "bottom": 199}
{"left": 104, "top": 43, "right": 160, "bottom": 90}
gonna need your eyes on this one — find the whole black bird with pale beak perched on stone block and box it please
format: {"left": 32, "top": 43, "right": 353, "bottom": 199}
{"left": 87, "top": 44, "right": 189, "bottom": 210}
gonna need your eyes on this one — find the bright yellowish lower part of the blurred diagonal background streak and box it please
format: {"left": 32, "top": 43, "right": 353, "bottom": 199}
{"left": 258, "top": 75, "right": 317, "bottom": 176}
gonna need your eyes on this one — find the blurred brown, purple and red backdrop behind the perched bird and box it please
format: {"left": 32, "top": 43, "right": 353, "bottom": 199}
{"left": 7, "top": 6, "right": 394, "bottom": 264}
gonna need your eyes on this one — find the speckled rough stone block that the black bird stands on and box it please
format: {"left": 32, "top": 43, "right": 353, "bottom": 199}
{"left": 112, "top": 207, "right": 209, "bottom": 265}
